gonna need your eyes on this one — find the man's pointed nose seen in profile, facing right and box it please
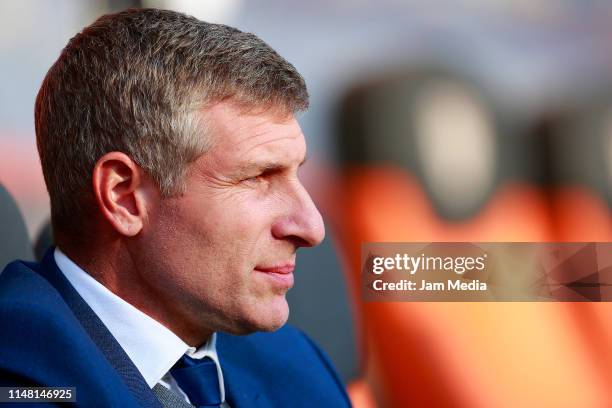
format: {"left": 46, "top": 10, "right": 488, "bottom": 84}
{"left": 272, "top": 182, "right": 325, "bottom": 247}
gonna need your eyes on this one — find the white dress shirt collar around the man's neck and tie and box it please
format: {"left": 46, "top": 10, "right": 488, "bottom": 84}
{"left": 54, "top": 248, "right": 228, "bottom": 407}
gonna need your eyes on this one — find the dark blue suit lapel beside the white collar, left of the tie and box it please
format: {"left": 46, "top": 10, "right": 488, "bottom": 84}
{"left": 40, "top": 247, "right": 161, "bottom": 408}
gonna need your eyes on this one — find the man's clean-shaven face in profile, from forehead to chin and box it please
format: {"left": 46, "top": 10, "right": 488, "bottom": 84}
{"left": 141, "top": 102, "right": 325, "bottom": 333}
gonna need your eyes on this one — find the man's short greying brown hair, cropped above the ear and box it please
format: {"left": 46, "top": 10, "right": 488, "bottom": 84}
{"left": 35, "top": 9, "right": 308, "bottom": 239}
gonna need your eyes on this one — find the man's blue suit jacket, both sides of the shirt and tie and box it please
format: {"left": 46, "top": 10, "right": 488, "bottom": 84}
{"left": 0, "top": 250, "right": 350, "bottom": 408}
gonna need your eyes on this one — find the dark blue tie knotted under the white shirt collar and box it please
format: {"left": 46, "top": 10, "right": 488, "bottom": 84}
{"left": 170, "top": 355, "right": 221, "bottom": 407}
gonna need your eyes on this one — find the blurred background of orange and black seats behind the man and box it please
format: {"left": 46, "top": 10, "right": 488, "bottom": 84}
{"left": 0, "top": 0, "right": 612, "bottom": 407}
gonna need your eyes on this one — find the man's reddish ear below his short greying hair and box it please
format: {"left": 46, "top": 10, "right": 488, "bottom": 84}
{"left": 93, "top": 152, "right": 148, "bottom": 237}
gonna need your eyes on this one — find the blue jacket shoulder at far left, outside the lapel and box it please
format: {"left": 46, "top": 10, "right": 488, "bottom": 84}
{"left": 0, "top": 261, "right": 139, "bottom": 406}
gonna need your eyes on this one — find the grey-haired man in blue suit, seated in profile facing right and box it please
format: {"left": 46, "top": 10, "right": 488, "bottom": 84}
{"left": 0, "top": 9, "right": 350, "bottom": 407}
